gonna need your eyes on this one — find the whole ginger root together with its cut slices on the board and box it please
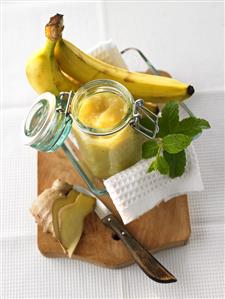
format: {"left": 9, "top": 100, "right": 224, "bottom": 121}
{"left": 30, "top": 180, "right": 95, "bottom": 257}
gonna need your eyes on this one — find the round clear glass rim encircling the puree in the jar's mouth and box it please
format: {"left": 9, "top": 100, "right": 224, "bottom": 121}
{"left": 72, "top": 79, "right": 134, "bottom": 136}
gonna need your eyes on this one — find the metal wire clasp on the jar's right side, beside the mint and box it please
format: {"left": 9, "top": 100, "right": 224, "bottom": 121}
{"left": 130, "top": 99, "right": 159, "bottom": 139}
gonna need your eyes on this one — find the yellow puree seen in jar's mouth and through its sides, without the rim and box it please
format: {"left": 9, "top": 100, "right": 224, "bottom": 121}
{"left": 74, "top": 92, "right": 142, "bottom": 178}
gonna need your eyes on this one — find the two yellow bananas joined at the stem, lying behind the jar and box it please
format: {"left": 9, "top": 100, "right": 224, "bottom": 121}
{"left": 27, "top": 14, "right": 194, "bottom": 103}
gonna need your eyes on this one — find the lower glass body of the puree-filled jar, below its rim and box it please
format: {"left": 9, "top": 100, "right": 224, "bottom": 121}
{"left": 72, "top": 125, "right": 142, "bottom": 179}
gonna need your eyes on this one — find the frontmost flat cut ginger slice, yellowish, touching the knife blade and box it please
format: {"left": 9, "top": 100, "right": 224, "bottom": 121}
{"left": 58, "top": 194, "right": 95, "bottom": 257}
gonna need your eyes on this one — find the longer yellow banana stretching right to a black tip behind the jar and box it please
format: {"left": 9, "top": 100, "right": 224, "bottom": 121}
{"left": 50, "top": 16, "right": 194, "bottom": 103}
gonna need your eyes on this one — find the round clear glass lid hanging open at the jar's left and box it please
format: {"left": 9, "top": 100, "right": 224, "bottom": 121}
{"left": 23, "top": 92, "right": 72, "bottom": 152}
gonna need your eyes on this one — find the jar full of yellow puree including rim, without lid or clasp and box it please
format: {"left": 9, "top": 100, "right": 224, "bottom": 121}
{"left": 71, "top": 80, "right": 143, "bottom": 179}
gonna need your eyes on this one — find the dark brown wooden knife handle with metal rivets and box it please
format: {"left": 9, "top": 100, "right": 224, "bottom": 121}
{"left": 102, "top": 215, "right": 177, "bottom": 283}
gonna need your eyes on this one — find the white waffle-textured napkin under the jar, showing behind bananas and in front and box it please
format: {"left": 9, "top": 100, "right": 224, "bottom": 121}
{"left": 90, "top": 41, "right": 203, "bottom": 224}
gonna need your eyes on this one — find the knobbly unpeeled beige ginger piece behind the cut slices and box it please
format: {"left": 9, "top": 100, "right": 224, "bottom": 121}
{"left": 30, "top": 180, "right": 72, "bottom": 236}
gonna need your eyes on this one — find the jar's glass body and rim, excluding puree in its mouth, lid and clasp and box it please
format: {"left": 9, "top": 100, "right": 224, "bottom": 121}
{"left": 70, "top": 80, "right": 143, "bottom": 179}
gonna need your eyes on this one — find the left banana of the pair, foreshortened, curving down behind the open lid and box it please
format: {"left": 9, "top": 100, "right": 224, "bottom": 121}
{"left": 26, "top": 14, "right": 80, "bottom": 95}
